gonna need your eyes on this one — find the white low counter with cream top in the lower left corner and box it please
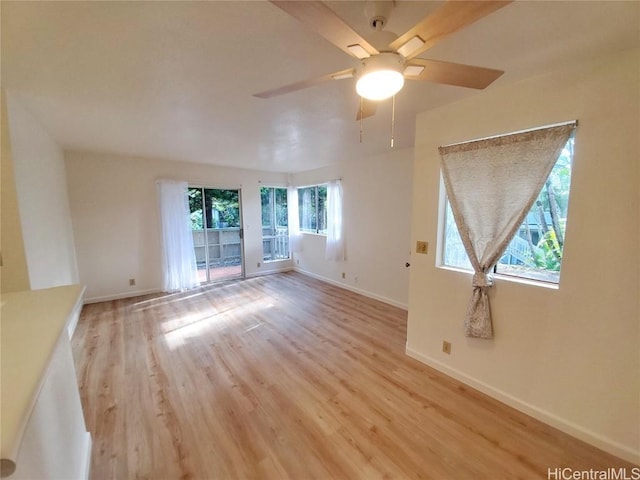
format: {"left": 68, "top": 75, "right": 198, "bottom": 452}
{"left": 0, "top": 285, "right": 91, "bottom": 480}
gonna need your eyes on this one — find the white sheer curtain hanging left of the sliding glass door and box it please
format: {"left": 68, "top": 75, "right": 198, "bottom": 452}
{"left": 158, "top": 180, "right": 200, "bottom": 292}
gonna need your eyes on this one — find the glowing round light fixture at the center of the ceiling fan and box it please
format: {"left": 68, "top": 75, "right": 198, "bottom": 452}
{"left": 356, "top": 53, "right": 404, "bottom": 100}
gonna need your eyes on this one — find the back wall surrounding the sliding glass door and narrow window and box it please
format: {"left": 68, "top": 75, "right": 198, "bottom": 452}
{"left": 66, "top": 152, "right": 291, "bottom": 301}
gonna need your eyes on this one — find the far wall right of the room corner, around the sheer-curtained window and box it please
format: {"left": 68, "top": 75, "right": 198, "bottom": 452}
{"left": 293, "top": 149, "right": 413, "bottom": 308}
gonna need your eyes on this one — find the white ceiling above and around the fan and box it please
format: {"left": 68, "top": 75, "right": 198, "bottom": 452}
{"left": 0, "top": 0, "right": 640, "bottom": 172}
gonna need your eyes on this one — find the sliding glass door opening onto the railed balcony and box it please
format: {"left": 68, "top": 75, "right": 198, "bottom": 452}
{"left": 189, "top": 187, "right": 244, "bottom": 283}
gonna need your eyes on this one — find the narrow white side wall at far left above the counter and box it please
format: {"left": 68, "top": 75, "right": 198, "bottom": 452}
{"left": 7, "top": 92, "right": 78, "bottom": 290}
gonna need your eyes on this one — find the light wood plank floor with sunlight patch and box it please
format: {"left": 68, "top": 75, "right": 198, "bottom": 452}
{"left": 73, "top": 273, "right": 631, "bottom": 480}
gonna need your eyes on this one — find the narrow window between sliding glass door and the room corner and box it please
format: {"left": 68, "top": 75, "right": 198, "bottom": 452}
{"left": 260, "top": 187, "right": 289, "bottom": 262}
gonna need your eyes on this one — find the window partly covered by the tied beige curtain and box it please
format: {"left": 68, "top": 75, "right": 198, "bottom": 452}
{"left": 442, "top": 136, "right": 574, "bottom": 283}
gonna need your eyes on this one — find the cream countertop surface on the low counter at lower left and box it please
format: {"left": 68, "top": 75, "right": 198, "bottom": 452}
{"left": 0, "top": 285, "right": 84, "bottom": 468}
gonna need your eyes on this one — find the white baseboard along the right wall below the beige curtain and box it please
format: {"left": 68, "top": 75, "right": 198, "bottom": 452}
{"left": 405, "top": 346, "right": 640, "bottom": 464}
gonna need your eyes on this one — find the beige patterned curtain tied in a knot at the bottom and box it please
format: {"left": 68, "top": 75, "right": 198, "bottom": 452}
{"left": 439, "top": 122, "right": 576, "bottom": 338}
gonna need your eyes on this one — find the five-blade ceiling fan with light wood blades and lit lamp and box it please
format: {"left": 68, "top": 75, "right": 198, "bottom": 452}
{"left": 254, "top": 0, "right": 513, "bottom": 120}
